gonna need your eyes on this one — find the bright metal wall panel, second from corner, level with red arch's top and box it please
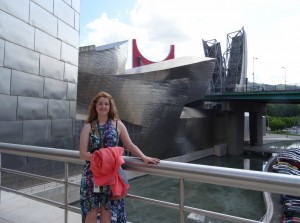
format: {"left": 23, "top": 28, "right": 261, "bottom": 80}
{"left": 35, "top": 29, "right": 61, "bottom": 59}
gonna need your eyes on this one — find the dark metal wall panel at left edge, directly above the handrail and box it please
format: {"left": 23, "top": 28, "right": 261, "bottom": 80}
{"left": 0, "top": 121, "right": 23, "bottom": 144}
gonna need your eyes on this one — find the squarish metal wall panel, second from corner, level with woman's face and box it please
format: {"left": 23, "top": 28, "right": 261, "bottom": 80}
{"left": 48, "top": 99, "right": 70, "bottom": 119}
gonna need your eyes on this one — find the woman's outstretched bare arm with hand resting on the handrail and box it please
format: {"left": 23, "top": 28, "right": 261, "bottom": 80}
{"left": 118, "top": 121, "right": 159, "bottom": 164}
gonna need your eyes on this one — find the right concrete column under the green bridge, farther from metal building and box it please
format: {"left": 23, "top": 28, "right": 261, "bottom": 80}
{"left": 249, "top": 112, "right": 263, "bottom": 146}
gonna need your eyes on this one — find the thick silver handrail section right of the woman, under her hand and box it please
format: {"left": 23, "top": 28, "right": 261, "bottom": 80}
{"left": 124, "top": 157, "right": 300, "bottom": 196}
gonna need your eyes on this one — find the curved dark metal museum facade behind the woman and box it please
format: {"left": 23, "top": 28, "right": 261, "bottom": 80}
{"left": 77, "top": 43, "right": 221, "bottom": 158}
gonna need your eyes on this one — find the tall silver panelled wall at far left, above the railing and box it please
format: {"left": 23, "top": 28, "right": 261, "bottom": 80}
{"left": 0, "top": 0, "right": 80, "bottom": 150}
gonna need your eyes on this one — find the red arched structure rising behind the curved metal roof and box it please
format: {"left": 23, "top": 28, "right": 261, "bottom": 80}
{"left": 132, "top": 39, "right": 175, "bottom": 68}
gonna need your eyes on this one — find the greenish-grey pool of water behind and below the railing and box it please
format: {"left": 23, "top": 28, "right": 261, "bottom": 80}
{"left": 126, "top": 155, "right": 267, "bottom": 223}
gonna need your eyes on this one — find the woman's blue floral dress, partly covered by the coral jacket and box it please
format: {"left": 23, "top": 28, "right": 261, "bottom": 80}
{"left": 80, "top": 119, "right": 126, "bottom": 223}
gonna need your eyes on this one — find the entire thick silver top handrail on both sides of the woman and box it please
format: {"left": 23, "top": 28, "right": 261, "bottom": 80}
{"left": 0, "top": 142, "right": 300, "bottom": 196}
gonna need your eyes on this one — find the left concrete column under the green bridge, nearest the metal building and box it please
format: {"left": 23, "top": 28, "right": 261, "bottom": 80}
{"left": 228, "top": 111, "right": 244, "bottom": 155}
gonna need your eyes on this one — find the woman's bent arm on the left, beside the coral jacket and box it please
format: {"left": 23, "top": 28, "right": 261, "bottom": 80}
{"left": 79, "top": 123, "right": 92, "bottom": 160}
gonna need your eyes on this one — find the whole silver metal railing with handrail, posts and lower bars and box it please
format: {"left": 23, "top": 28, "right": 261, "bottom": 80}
{"left": 0, "top": 143, "right": 300, "bottom": 223}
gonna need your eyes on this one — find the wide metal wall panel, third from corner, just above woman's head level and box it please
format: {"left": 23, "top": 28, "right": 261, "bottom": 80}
{"left": 11, "top": 70, "right": 44, "bottom": 98}
